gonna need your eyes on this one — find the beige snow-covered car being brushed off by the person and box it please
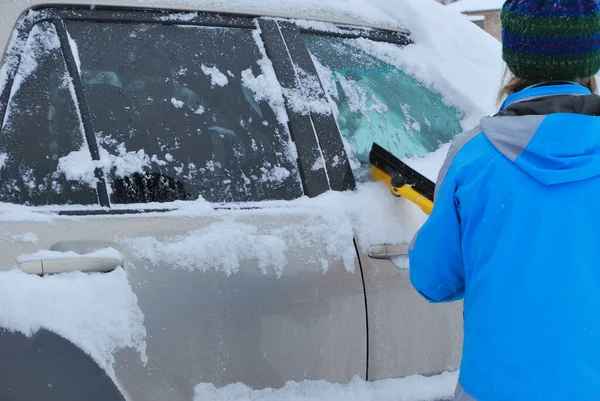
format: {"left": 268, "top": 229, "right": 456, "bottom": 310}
{"left": 0, "top": 0, "right": 499, "bottom": 401}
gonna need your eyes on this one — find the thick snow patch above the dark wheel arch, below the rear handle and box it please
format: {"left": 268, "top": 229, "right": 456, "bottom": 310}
{"left": 0, "top": 268, "right": 147, "bottom": 377}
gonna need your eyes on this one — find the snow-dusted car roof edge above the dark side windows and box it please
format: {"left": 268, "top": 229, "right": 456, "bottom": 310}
{"left": 0, "top": 0, "right": 407, "bottom": 59}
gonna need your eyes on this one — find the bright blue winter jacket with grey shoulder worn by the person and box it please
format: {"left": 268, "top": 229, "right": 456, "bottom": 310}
{"left": 410, "top": 83, "right": 600, "bottom": 401}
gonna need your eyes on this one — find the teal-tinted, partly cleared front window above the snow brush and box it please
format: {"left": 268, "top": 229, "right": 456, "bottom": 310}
{"left": 304, "top": 34, "right": 461, "bottom": 178}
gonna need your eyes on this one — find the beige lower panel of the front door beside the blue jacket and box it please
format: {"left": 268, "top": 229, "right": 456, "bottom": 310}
{"left": 360, "top": 252, "right": 463, "bottom": 380}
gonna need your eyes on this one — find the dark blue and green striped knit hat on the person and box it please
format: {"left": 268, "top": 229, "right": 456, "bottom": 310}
{"left": 501, "top": 0, "right": 600, "bottom": 80}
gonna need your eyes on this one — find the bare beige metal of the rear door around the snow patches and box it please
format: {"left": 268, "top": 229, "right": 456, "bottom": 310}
{"left": 0, "top": 210, "right": 367, "bottom": 401}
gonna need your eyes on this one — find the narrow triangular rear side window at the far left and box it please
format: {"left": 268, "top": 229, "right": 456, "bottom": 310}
{"left": 0, "top": 22, "right": 97, "bottom": 205}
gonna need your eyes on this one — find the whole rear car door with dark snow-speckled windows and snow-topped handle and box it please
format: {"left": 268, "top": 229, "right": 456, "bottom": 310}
{"left": 0, "top": 8, "right": 367, "bottom": 401}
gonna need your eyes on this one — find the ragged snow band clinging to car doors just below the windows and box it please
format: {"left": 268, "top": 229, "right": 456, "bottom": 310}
{"left": 118, "top": 183, "right": 426, "bottom": 276}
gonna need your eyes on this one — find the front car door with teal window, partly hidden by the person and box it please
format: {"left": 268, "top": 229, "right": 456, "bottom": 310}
{"left": 302, "top": 24, "right": 462, "bottom": 380}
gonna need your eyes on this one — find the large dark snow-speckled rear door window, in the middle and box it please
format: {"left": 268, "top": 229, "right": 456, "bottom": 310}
{"left": 67, "top": 22, "right": 302, "bottom": 203}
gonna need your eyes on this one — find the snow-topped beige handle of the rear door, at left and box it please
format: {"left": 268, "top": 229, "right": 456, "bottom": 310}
{"left": 17, "top": 248, "right": 123, "bottom": 275}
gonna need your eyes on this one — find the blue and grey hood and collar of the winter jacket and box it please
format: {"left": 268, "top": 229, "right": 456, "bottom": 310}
{"left": 481, "top": 84, "right": 600, "bottom": 185}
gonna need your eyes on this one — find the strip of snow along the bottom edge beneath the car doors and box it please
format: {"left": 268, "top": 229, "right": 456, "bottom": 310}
{"left": 194, "top": 373, "right": 458, "bottom": 401}
